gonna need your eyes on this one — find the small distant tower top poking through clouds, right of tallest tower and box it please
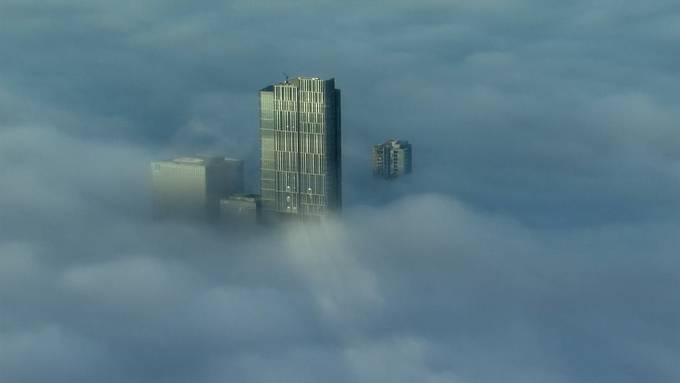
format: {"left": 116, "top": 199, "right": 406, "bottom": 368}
{"left": 373, "top": 139, "right": 412, "bottom": 178}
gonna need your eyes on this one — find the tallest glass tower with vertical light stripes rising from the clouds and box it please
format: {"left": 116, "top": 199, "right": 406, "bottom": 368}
{"left": 260, "top": 77, "right": 342, "bottom": 217}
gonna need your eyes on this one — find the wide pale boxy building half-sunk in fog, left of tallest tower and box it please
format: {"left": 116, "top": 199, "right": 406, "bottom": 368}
{"left": 151, "top": 157, "right": 243, "bottom": 219}
